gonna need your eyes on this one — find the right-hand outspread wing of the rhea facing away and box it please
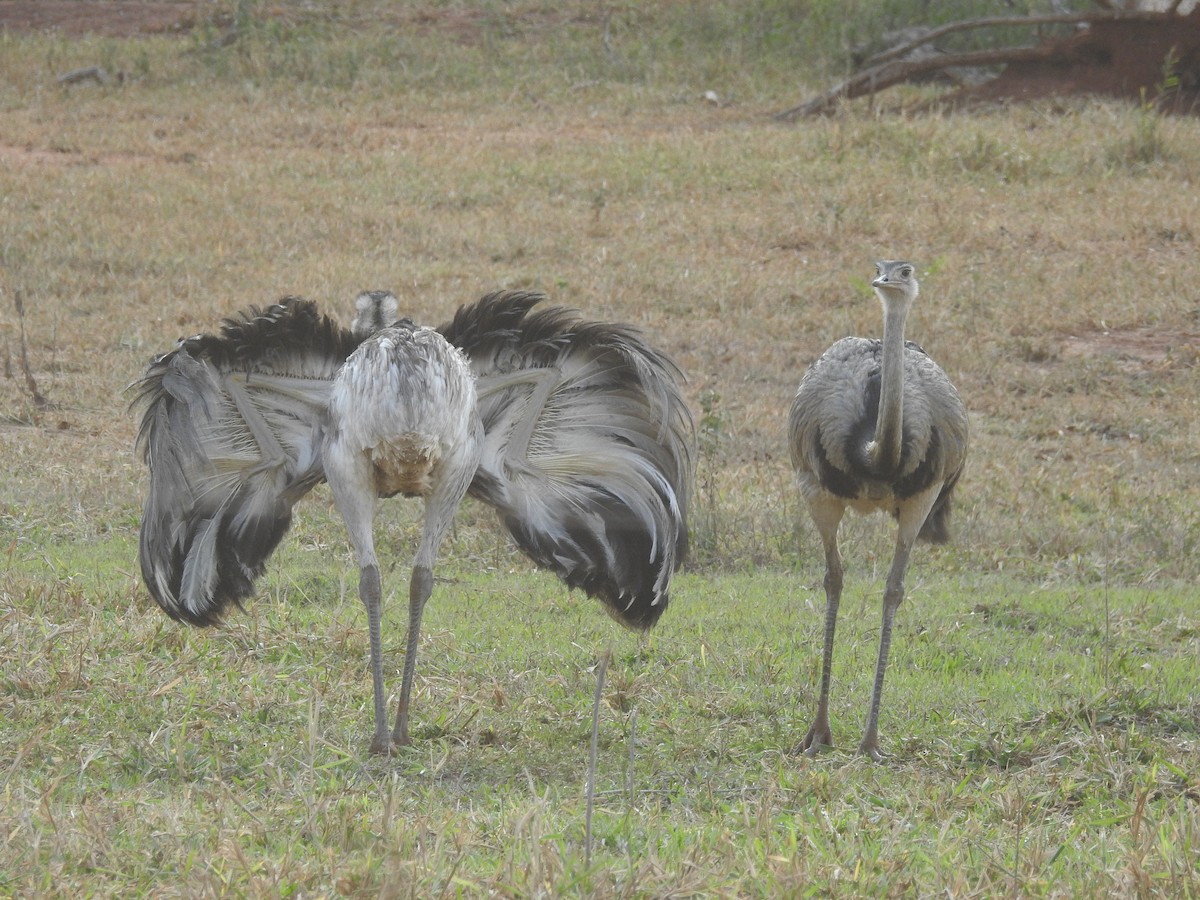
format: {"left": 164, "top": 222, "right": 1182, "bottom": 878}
{"left": 440, "top": 292, "right": 694, "bottom": 629}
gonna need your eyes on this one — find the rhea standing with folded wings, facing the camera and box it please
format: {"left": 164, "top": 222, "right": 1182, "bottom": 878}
{"left": 788, "top": 259, "right": 967, "bottom": 760}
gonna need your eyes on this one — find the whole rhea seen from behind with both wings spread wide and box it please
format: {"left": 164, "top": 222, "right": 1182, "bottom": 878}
{"left": 134, "top": 292, "right": 694, "bottom": 754}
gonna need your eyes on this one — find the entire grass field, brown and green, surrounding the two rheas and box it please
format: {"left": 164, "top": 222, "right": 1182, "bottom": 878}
{"left": 0, "top": 0, "right": 1200, "bottom": 896}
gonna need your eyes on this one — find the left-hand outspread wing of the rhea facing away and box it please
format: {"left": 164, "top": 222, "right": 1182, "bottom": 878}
{"left": 134, "top": 298, "right": 356, "bottom": 625}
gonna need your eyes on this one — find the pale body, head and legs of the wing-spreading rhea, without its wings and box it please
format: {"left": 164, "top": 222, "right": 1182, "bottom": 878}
{"left": 324, "top": 292, "right": 484, "bottom": 754}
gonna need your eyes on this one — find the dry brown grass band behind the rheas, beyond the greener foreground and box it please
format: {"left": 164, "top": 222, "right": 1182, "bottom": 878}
{"left": 0, "top": 65, "right": 1200, "bottom": 578}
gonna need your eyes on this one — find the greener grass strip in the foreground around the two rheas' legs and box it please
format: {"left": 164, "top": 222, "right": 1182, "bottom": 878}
{"left": 0, "top": 547, "right": 1200, "bottom": 896}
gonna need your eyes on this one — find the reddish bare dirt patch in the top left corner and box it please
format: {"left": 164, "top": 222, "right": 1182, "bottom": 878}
{"left": 0, "top": 0, "right": 204, "bottom": 37}
